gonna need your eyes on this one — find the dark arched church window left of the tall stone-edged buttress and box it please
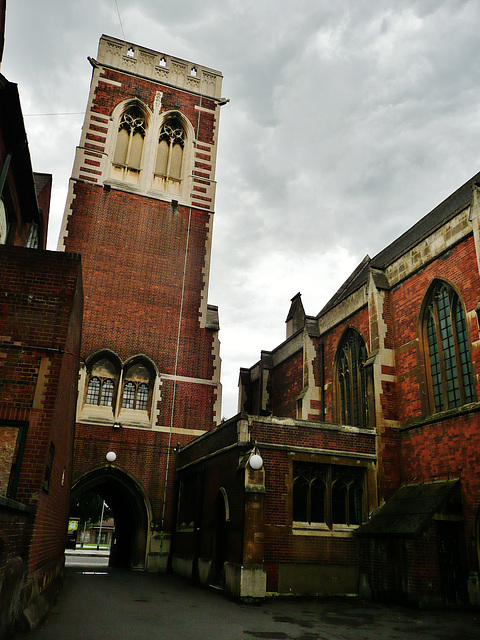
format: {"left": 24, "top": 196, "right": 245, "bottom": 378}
{"left": 337, "top": 330, "right": 368, "bottom": 427}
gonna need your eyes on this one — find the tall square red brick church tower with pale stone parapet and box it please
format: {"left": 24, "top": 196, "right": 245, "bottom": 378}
{"left": 58, "top": 36, "right": 225, "bottom": 571}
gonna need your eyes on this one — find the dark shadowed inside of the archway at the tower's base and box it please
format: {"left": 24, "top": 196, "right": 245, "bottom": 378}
{"left": 70, "top": 467, "right": 151, "bottom": 570}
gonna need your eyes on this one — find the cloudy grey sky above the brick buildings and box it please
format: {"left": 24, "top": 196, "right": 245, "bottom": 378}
{"left": 2, "top": 0, "right": 480, "bottom": 417}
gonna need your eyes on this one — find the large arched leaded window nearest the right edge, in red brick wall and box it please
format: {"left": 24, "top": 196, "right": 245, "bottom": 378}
{"left": 423, "top": 282, "right": 475, "bottom": 411}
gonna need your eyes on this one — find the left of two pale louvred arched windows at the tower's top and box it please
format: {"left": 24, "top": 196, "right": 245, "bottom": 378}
{"left": 113, "top": 105, "right": 146, "bottom": 180}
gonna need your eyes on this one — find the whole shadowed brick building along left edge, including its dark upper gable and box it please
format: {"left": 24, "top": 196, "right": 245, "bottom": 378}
{"left": 0, "top": 3, "right": 83, "bottom": 638}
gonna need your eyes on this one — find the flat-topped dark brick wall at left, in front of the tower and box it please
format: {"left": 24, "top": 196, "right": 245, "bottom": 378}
{"left": 0, "top": 246, "right": 83, "bottom": 632}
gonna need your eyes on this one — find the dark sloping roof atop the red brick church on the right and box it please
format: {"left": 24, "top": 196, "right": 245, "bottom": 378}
{"left": 317, "top": 173, "right": 480, "bottom": 318}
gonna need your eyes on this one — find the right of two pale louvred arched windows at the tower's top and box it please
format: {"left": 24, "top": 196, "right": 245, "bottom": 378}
{"left": 155, "top": 116, "right": 186, "bottom": 190}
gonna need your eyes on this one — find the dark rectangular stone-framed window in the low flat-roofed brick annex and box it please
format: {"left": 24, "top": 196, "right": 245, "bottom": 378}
{"left": 292, "top": 462, "right": 365, "bottom": 529}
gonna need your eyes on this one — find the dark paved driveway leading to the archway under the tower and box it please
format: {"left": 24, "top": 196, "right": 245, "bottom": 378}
{"left": 15, "top": 565, "right": 480, "bottom": 640}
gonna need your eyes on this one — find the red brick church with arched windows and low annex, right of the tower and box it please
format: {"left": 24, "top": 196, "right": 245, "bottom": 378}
{"left": 174, "top": 174, "right": 480, "bottom": 605}
